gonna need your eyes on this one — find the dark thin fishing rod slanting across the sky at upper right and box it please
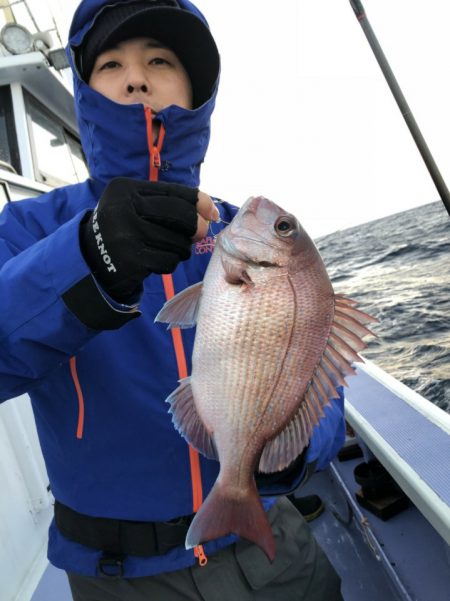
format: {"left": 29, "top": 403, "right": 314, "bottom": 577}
{"left": 350, "top": 0, "right": 450, "bottom": 215}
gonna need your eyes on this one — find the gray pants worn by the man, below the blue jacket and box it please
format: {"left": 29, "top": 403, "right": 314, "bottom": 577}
{"left": 68, "top": 498, "right": 342, "bottom": 601}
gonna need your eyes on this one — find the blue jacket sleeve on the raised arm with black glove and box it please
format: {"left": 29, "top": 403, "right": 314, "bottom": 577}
{"left": 0, "top": 196, "right": 137, "bottom": 401}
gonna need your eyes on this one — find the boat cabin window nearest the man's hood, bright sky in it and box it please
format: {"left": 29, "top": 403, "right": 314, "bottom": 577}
{"left": 25, "top": 93, "right": 89, "bottom": 186}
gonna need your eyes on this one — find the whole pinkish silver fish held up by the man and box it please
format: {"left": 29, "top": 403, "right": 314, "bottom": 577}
{"left": 157, "top": 197, "right": 374, "bottom": 560}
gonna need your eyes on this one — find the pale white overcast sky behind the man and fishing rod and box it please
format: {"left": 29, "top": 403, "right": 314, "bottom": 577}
{"left": 37, "top": 0, "right": 450, "bottom": 237}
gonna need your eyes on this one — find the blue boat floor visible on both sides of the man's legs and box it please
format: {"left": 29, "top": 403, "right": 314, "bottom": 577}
{"left": 31, "top": 459, "right": 450, "bottom": 601}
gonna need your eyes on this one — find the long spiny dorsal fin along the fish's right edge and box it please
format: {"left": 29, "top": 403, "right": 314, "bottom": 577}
{"left": 258, "top": 295, "right": 377, "bottom": 473}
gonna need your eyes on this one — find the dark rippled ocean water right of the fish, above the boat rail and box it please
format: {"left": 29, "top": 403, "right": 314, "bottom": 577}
{"left": 315, "top": 201, "right": 450, "bottom": 413}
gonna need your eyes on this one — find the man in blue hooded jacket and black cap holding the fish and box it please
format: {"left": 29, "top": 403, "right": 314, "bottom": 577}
{"left": 0, "top": 0, "right": 344, "bottom": 601}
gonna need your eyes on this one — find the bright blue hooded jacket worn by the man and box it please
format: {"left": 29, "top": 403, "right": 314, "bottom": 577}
{"left": 0, "top": 0, "right": 344, "bottom": 577}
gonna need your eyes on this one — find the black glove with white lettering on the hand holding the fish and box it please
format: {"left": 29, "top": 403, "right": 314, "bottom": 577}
{"left": 80, "top": 178, "right": 198, "bottom": 301}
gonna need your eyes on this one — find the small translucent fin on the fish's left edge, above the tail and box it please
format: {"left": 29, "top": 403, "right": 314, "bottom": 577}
{"left": 166, "top": 378, "right": 218, "bottom": 460}
